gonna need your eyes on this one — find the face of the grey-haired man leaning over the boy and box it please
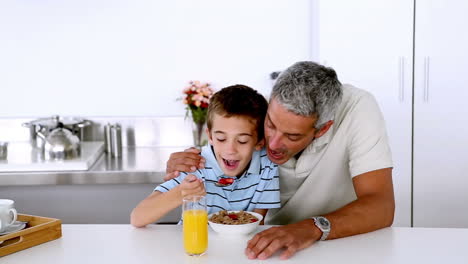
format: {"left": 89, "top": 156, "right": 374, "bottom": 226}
{"left": 265, "top": 98, "right": 318, "bottom": 164}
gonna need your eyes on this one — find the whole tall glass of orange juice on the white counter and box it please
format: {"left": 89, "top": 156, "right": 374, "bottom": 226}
{"left": 182, "top": 196, "right": 208, "bottom": 256}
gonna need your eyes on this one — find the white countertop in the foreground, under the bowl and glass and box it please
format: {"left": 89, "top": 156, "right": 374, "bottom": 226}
{"left": 0, "top": 225, "right": 468, "bottom": 264}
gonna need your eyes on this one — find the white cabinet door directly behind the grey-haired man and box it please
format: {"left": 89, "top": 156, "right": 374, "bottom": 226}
{"left": 314, "top": 0, "right": 413, "bottom": 226}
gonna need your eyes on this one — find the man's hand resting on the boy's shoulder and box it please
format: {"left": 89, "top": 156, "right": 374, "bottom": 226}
{"left": 164, "top": 148, "right": 205, "bottom": 181}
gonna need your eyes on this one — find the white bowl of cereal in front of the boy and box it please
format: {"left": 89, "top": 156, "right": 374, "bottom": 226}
{"left": 208, "top": 210, "right": 263, "bottom": 235}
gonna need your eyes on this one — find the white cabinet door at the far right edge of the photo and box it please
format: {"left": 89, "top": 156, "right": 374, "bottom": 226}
{"left": 414, "top": 0, "right": 468, "bottom": 228}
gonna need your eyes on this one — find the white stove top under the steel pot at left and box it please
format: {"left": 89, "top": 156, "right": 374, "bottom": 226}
{"left": 0, "top": 141, "right": 104, "bottom": 172}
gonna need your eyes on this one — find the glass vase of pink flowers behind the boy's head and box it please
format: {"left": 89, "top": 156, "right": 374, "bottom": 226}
{"left": 183, "top": 81, "right": 213, "bottom": 147}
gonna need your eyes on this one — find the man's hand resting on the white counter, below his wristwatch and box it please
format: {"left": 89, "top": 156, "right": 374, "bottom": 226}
{"left": 245, "top": 219, "right": 322, "bottom": 259}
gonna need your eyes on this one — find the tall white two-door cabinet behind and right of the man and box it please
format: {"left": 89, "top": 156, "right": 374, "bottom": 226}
{"left": 315, "top": 0, "right": 468, "bottom": 227}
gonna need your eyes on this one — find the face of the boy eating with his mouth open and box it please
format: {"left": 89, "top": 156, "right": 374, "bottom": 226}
{"left": 208, "top": 114, "right": 263, "bottom": 177}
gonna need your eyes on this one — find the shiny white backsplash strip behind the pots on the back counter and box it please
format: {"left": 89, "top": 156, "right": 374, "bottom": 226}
{"left": 0, "top": 116, "right": 193, "bottom": 147}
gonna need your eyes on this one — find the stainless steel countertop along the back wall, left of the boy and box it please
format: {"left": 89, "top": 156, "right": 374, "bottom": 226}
{"left": 0, "top": 146, "right": 188, "bottom": 187}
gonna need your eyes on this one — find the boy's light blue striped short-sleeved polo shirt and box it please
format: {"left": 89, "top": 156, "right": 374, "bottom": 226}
{"left": 154, "top": 145, "right": 281, "bottom": 214}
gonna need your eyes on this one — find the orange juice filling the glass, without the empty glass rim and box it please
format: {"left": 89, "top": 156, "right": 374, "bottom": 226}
{"left": 182, "top": 209, "right": 208, "bottom": 255}
